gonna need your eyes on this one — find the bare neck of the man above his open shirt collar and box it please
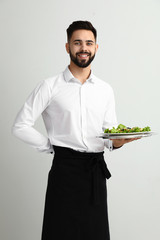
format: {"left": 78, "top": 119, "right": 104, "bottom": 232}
{"left": 69, "top": 61, "right": 91, "bottom": 84}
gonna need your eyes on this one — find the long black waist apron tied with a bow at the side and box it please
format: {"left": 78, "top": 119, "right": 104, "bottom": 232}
{"left": 42, "top": 146, "right": 111, "bottom": 240}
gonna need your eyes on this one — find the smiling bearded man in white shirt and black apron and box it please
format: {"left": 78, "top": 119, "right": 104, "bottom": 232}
{"left": 13, "top": 21, "right": 138, "bottom": 240}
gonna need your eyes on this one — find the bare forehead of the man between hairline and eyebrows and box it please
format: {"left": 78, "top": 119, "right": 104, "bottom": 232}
{"left": 71, "top": 29, "right": 95, "bottom": 41}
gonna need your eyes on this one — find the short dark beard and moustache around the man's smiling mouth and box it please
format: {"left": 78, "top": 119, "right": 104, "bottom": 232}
{"left": 69, "top": 51, "right": 95, "bottom": 68}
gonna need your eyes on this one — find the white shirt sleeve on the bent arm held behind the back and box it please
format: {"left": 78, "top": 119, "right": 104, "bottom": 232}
{"left": 12, "top": 81, "right": 53, "bottom": 153}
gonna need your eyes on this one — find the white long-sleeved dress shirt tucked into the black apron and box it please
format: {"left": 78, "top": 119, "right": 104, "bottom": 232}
{"left": 12, "top": 67, "right": 117, "bottom": 153}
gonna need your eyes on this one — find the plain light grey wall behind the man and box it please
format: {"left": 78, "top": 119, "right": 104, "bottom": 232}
{"left": 0, "top": 0, "right": 160, "bottom": 240}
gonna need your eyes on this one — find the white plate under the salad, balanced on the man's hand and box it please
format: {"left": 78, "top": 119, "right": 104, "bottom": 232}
{"left": 99, "top": 132, "right": 155, "bottom": 139}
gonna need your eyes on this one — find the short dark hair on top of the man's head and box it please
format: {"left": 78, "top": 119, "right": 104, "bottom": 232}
{"left": 67, "top": 21, "right": 97, "bottom": 42}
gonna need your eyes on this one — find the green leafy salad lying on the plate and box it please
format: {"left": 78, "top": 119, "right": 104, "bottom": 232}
{"left": 104, "top": 124, "right": 151, "bottom": 133}
